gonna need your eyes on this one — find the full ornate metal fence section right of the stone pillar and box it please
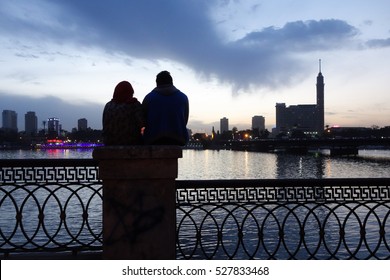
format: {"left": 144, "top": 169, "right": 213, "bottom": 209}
{"left": 176, "top": 179, "right": 390, "bottom": 259}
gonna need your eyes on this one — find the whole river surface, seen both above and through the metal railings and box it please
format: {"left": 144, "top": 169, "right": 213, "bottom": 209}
{"left": 0, "top": 149, "right": 390, "bottom": 259}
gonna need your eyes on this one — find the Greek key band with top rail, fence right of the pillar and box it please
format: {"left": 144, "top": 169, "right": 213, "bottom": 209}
{"left": 176, "top": 178, "right": 390, "bottom": 204}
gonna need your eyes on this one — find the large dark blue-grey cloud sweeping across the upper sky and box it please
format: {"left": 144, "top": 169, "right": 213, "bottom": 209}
{"left": 0, "top": 0, "right": 378, "bottom": 91}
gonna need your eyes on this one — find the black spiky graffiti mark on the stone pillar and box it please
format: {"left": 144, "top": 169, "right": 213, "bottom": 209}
{"left": 105, "top": 192, "right": 165, "bottom": 245}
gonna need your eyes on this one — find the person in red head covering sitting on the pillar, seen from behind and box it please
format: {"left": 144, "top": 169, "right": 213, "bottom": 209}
{"left": 103, "top": 81, "right": 145, "bottom": 146}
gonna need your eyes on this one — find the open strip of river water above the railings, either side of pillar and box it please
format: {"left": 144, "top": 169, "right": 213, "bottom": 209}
{"left": 0, "top": 149, "right": 390, "bottom": 180}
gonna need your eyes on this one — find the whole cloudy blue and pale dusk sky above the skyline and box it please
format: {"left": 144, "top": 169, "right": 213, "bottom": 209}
{"left": 0, "top": 0, "right": 390, "bottom": 133}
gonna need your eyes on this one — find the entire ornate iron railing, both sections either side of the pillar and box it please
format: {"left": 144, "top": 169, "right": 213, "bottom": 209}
{"left": 0, "top": 159, "right": 390, "bottom": 259}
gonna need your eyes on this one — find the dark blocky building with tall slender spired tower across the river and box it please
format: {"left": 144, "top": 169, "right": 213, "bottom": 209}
{"left": 275, "top": 60, "right": 325, "bottom": 135}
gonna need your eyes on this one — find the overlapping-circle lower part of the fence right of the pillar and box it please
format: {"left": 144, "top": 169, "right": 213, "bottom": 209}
{"left": 177, "top": 202, "right": 390, "bottom": 259}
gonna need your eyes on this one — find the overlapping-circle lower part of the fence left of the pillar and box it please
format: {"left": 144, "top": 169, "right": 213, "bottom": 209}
{"left": 0, "top": 183, "right": 102, "bottom": 252}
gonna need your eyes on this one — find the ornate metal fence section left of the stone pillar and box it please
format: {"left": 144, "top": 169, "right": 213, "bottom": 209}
{"left": 0, "top": 159, "right": 102, "bottom": 256}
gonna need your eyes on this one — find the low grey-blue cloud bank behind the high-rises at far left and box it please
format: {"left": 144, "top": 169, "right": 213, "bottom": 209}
{"left": 0, "top": 92, "right": 104, "bottom": 131}
